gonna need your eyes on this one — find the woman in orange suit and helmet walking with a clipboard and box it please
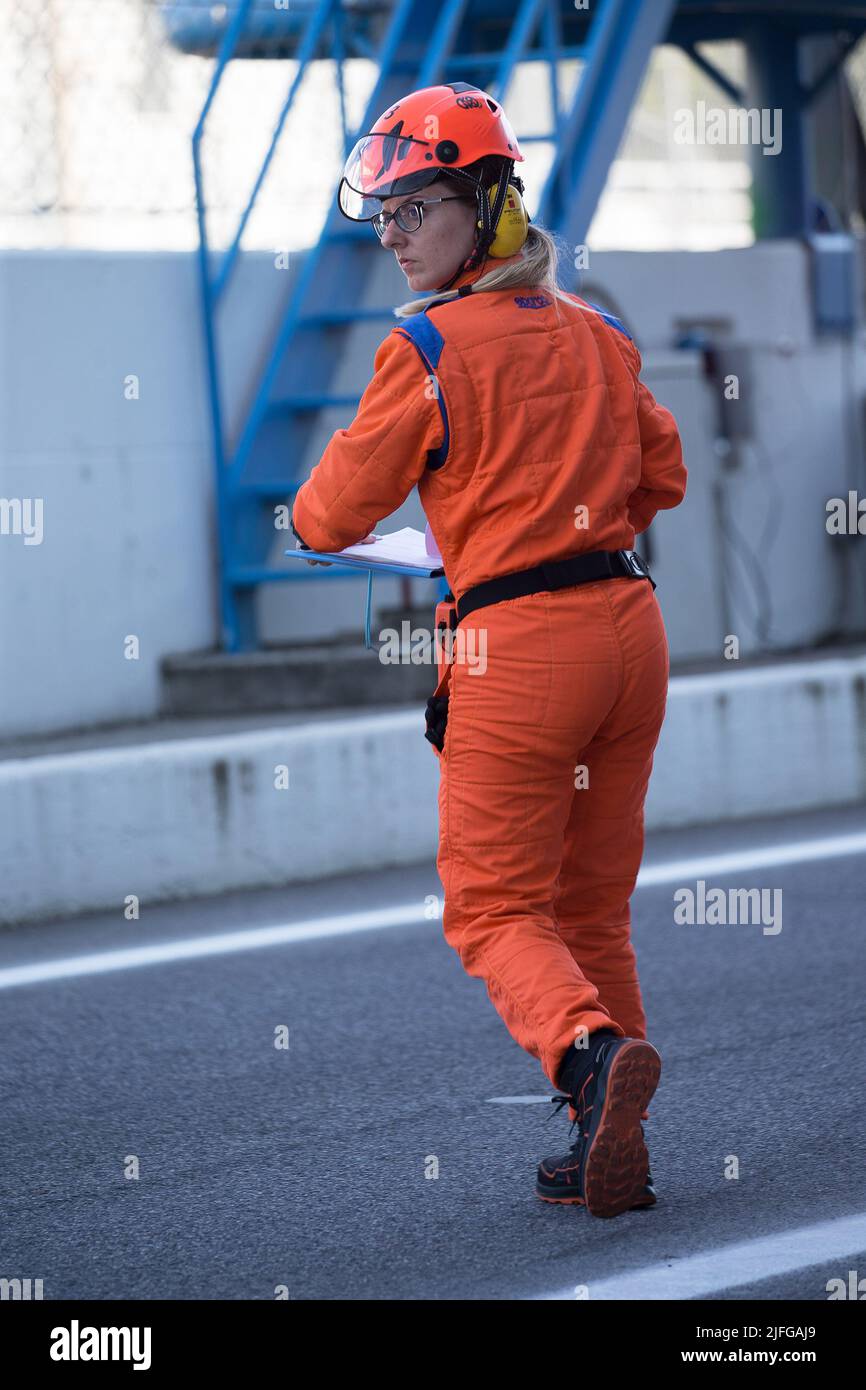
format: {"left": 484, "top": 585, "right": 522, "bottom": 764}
{"left": 293, "top": 82, "right": 685, "bottom": 1216}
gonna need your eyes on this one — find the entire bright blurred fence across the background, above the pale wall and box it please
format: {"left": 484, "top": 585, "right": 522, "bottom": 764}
{"left": 0, "top": 0, "right": 866, "bottom": 250}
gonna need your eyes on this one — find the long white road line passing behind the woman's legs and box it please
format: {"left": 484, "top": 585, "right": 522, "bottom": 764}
{"left": 0, "top": 831, "right": 866, "bottom": 990}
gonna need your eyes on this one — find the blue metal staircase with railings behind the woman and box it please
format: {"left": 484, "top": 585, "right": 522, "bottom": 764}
{"left": 180, "top": 0, "right": 676, "bottom": 652}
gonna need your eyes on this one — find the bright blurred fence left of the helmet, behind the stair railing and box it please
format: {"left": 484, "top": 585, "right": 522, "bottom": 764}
{"left": 0, "top": 0, "right": 361, "bottom": 249}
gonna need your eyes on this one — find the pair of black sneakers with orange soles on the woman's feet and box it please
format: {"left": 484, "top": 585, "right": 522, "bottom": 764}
{"left": 535, "top": 1036, "right": 662, "bottom": 1216}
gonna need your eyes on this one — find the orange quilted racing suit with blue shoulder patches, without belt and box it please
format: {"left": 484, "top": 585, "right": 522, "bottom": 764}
{"left": 292, "top": 257, "right": 687, "bottom": 1095}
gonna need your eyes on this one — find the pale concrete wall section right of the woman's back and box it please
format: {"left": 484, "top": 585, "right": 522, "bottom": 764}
{"left": 592, "top": 242, "right": 866, "bottom": 655}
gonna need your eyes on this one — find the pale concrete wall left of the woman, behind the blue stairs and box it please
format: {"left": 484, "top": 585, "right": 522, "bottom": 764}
{"left": 0, "top": 252, "right": 414, "bottom": 737}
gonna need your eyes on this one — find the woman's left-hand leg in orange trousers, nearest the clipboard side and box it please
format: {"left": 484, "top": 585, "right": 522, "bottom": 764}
{"left": 436, "top": 581, "right": 637, "bottom": 1086}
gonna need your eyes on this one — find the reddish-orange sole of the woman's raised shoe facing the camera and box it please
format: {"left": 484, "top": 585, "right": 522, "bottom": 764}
{"left": 582, "top": 1038, "right": 662, "bottom": 1216}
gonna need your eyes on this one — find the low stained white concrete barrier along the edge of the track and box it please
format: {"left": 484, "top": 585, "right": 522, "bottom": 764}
{"left": 0, "top": 655, "right": 866, "bottom": 923}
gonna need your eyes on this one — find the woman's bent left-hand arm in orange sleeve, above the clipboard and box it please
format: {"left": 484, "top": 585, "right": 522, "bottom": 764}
{"left": 292, "top": 332, "right": 445, "bottom": 550}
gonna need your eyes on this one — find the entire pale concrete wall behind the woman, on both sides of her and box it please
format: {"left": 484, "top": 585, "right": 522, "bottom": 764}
{"left": 0, "top": 243, "right": 866, "bottom": 737}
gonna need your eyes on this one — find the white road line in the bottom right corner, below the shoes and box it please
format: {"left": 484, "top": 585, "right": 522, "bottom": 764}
{"left": 539, "top": 1212, "right": 866, "bottom": 1301}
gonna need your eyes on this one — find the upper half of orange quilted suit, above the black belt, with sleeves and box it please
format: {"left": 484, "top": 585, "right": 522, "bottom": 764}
{"left": 293, "top": 260, "right": 687, "bottom": 598}
